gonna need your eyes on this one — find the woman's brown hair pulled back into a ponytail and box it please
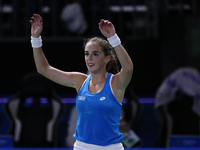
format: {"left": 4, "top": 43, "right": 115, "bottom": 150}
{"left": 83, "top": 37, "right": 119, "bottom": 74}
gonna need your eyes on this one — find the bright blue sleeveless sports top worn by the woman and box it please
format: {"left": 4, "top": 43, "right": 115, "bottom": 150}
{"left": 73, "top": 73, "right": 123, "bottom": 145}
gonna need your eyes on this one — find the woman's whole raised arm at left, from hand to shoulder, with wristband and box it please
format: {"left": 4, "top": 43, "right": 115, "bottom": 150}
{"left": 30, "top": 14, "right": 87, "bottom": 91}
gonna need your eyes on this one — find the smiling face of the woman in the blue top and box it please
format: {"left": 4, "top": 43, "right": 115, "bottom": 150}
{"left": 85, "top": 42, "right": 110, "bottom": 73}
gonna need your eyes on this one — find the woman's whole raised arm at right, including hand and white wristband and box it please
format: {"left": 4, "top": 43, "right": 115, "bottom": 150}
{"left": 99, "top": 19, "right": 133, "bottom": 101}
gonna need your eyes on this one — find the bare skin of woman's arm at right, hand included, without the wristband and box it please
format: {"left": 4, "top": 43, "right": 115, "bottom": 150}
{"left": 99, "top": 19, "right": 133, "bottom": 102}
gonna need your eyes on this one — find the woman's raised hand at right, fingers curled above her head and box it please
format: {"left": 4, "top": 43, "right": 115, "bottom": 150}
{"left": 99, "top": 19, "right": 115, "bottom": 38}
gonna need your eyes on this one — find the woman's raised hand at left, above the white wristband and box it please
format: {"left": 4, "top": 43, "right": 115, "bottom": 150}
{"left": 29, "top": 14, "right": 43, "bottom": 38}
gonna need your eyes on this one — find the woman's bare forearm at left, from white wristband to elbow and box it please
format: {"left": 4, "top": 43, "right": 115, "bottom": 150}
{"left": 33, "top": 47, "right": 50, "bottom": 74}
